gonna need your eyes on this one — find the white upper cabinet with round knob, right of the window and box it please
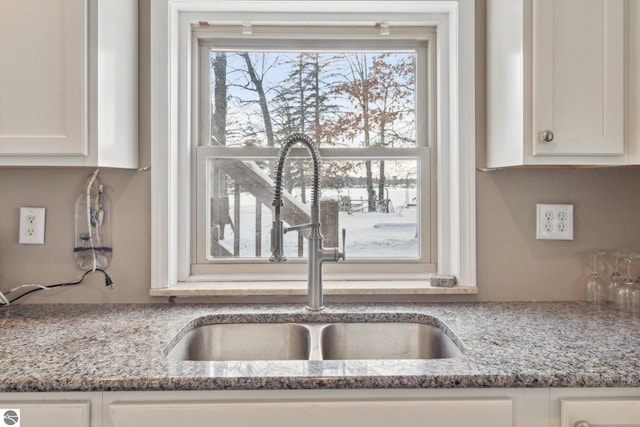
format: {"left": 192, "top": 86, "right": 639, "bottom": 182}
{"left": 487, "top": 0, "right": 629, "bottom": 168}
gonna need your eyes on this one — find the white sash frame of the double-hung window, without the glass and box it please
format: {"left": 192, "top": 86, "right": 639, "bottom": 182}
{"left": 191, "top": 30, "right": 436, "bottom": 282}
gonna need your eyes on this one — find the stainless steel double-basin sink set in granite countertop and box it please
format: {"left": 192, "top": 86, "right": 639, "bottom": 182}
{"left": 165, "top": 321, "right": 464, "bottom": 361}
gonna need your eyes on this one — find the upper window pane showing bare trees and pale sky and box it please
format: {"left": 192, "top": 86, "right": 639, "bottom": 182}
{"left": 210, "top": 50, "right": 416, "bottom": 147}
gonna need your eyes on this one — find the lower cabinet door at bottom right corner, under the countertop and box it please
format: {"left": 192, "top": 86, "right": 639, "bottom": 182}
{"left": 560, "top": 398, "right": 640, "bottom": 427}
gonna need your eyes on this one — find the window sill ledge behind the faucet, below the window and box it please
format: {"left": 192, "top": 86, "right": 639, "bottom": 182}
{"left": 150, "top": 280, "right": 478, "bottom": 297}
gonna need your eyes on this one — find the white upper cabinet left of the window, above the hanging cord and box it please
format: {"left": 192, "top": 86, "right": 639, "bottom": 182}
{"left": 0, "top": 0, "right": 138, "bottom": 168}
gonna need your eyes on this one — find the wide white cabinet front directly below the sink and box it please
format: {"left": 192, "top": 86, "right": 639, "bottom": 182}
{"left": 104, "top": 389, "right": 548, "bottom": 427}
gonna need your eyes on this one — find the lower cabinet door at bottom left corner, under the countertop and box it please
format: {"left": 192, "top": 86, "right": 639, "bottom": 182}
{"left": 0, "top": 401, "right": 90, "bottom": 427}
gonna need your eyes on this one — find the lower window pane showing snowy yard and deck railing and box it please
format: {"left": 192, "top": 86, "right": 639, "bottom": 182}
{"left": 207, "top": 159, "right": 420, "bottom": 260}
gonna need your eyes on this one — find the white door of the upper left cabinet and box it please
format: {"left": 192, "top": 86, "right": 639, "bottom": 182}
{"left": 0, "top": 0, "right": 87, "bottom": 156}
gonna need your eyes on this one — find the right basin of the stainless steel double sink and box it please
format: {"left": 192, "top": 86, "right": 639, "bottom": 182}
{"left": 321, "top": 323, "right": 461, "bottom": 360}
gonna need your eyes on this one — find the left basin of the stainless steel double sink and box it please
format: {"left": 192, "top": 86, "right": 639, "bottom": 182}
{"left": 168, "top": 323, "right": 310, "bottom": 360}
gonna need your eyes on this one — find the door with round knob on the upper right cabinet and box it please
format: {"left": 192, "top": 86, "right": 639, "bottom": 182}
{"left": 532, "top": 0, "right": 625, "bottom": 156}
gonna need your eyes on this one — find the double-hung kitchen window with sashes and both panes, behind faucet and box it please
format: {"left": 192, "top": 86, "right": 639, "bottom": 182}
{"left": 191, "top": 29, "right": 435, "bottom": 278}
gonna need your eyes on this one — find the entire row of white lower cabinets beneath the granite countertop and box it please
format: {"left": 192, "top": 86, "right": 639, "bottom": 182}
{"left": 5, "top": 387, "right": 640, "bottom": 427}
